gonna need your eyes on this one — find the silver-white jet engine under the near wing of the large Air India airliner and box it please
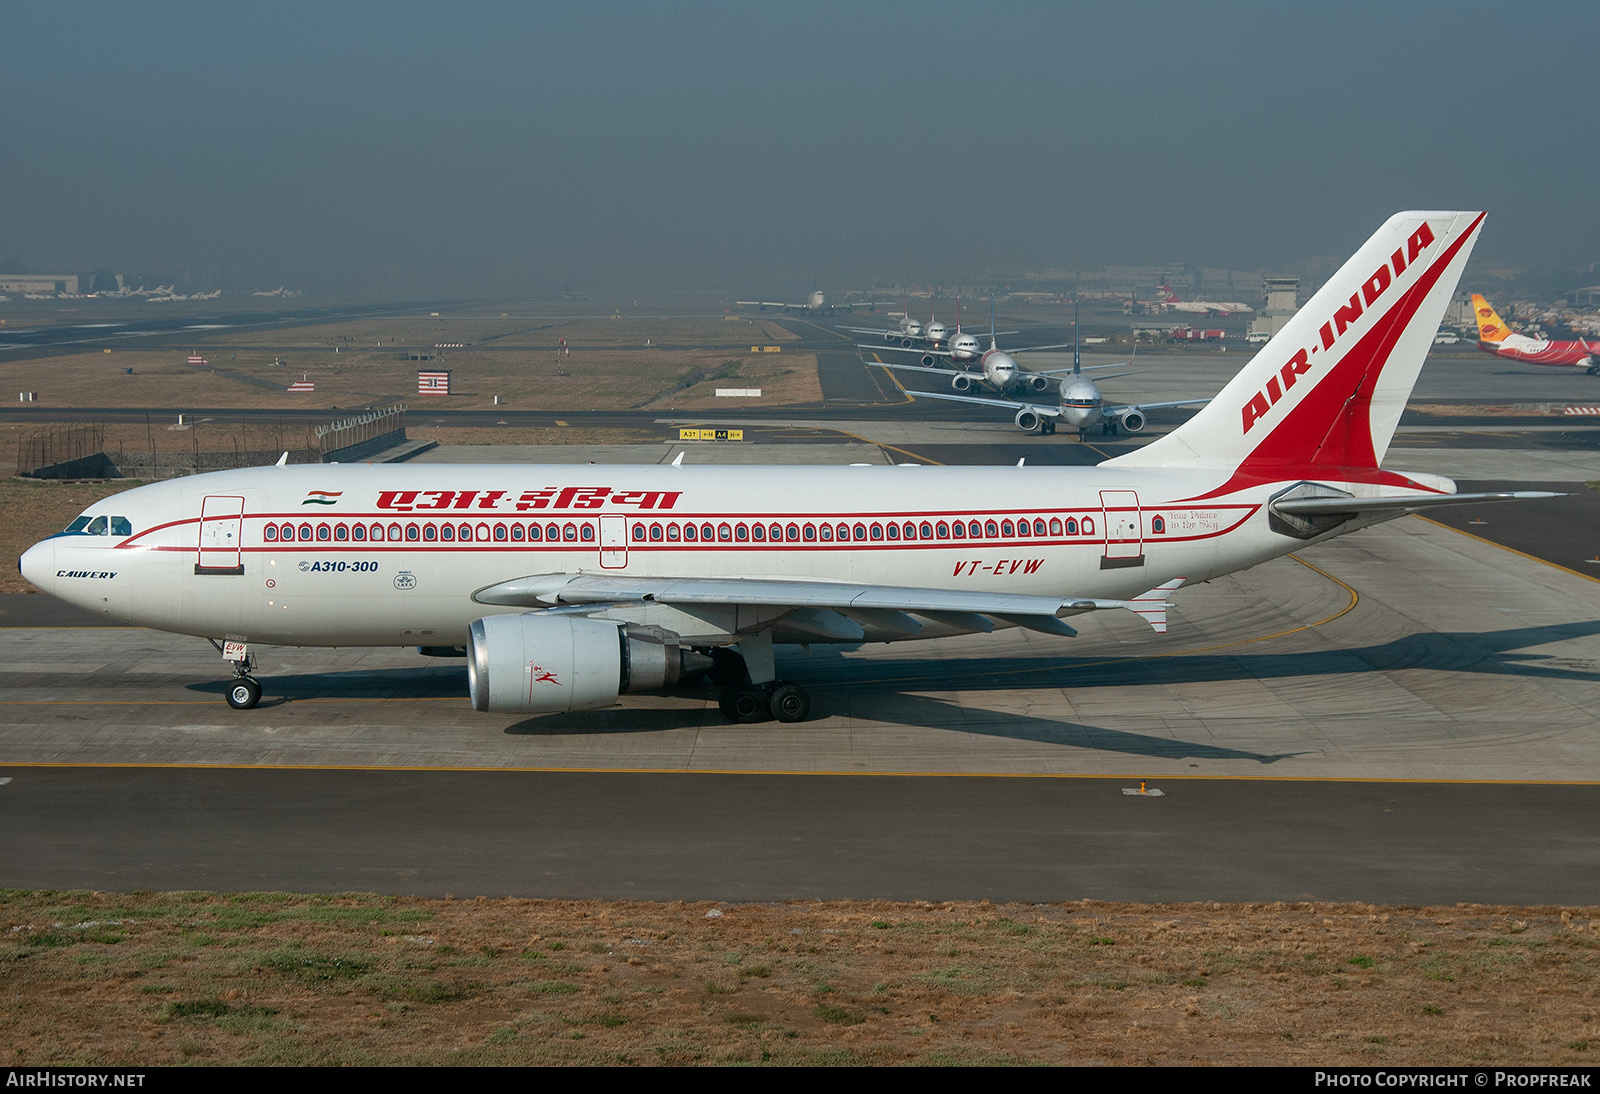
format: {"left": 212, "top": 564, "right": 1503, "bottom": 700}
{"left": 467, "top": 613, "right": 710, "bottom": 713}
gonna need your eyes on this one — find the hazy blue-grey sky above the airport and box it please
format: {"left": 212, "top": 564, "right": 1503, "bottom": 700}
{"left": 0, "top": 0, "right": 1600, "bottom": 296}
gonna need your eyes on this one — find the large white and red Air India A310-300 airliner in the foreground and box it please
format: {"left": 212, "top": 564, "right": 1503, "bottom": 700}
{"left": 22, "top": 213, "right": 1550, "bottom": 721}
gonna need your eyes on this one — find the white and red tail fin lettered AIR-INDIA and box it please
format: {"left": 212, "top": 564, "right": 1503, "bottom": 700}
{"left": 1107, "top": 211, "right": 1485, "bottom": 479}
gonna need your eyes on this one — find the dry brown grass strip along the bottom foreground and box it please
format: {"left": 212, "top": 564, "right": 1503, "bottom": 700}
{"left": 0, "top": 892, "right": 1600, "bottom": 1067}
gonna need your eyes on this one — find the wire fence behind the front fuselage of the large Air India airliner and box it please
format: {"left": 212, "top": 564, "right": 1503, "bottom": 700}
{"left": 16, "top": 403, "right": 406, "bottom": 481}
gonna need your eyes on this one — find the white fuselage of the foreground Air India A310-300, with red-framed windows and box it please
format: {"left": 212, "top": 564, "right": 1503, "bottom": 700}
{"left": 22, "top": 464, "right": 1365, "bottom": 646}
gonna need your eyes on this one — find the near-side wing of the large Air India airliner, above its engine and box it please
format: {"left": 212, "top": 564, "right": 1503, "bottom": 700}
{"left": 472, "top": 574, "right": 1184, "bottom": 637}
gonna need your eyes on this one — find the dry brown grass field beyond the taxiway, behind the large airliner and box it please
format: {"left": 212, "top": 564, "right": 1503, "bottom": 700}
{"left": 6, "top": 320, "right": 822, "bottom": 417}
